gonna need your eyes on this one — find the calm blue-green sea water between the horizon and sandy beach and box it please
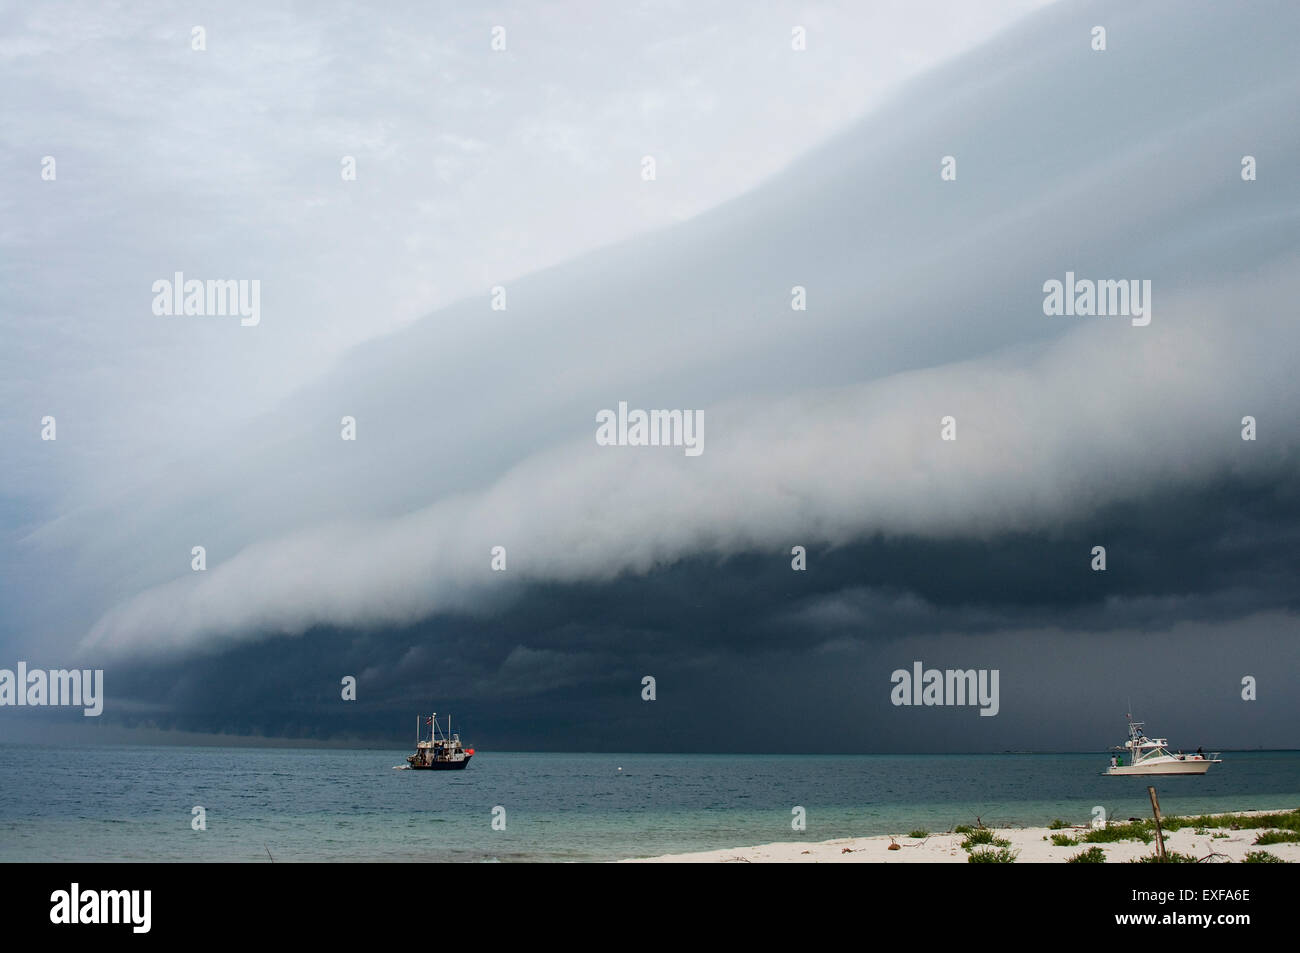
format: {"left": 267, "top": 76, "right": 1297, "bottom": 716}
{"left": 0, "top": 745, "right": 1300, "bottom": 862}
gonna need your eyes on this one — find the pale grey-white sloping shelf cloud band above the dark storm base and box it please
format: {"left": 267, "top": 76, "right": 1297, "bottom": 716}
{"left": 50, "top": 5, "right": 1300, "bottom": 651}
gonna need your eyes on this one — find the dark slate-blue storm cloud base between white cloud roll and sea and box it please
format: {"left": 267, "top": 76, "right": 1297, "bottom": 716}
{"left": 58, "top": 473, "right": 1300, "bottom": 750}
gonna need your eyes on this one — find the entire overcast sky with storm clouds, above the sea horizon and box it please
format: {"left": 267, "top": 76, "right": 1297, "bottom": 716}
{"left": 0, "top": 1, "right": 1300, "bottom": 750}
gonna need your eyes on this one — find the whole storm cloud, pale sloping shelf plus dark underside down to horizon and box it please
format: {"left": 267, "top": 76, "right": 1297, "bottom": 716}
{"left": 2, "top": 4, "right": 1300, "bottom": 750}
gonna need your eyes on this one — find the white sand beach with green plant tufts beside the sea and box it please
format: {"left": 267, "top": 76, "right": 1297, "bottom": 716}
{"left": 623, "top": 811, "right": 1300, "bottom": 863}
